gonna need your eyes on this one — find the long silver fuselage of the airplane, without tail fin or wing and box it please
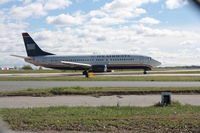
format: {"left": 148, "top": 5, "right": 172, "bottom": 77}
{"left": 25, "top": 55, "right": 160, "bottom": 70}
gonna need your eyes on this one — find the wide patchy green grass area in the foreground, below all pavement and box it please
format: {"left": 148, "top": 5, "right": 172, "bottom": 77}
{"left": 0, "top": 103, "right": 200, "bottom": 132}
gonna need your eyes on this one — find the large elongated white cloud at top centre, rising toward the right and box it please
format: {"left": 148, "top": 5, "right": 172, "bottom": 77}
{"left": 46, "top": 0, "right": 158, "bottom": 26}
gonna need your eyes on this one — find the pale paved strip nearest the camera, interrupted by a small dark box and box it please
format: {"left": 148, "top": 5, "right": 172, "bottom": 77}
{"left": 0, "top": 95, "right": 200, "bottom": 108}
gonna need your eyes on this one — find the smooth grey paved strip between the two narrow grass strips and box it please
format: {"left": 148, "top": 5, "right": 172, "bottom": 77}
{"left": 0, "top": 81, "right": 200, "bottom": 91}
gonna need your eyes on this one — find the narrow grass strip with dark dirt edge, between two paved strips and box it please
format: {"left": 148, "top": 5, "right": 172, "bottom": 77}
{"left": 0, "top": 87, "right": 200, "bottom": 97}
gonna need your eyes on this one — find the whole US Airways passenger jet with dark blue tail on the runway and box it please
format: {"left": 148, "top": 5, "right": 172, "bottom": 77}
{"left": 12, "top": 33, "right": 161, "bottom": 75}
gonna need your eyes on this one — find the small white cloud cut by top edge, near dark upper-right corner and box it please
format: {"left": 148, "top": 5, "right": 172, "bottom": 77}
{"left": 165, "top": 0, "right": 188, "bottom": 9}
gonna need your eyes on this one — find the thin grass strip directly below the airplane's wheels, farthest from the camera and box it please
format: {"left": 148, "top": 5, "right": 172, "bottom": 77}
{"left": 0, "top": 76, "right": 200, "bottom": 81}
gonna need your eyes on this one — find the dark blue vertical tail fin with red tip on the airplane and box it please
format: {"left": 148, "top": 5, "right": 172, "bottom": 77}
{"left": 22, "top": 33, "right": 54, "bottom": 56}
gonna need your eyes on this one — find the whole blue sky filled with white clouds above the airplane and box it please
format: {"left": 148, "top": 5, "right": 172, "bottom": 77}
{"left": 0, "top": 0, "right": 200, "bottom": 67}
